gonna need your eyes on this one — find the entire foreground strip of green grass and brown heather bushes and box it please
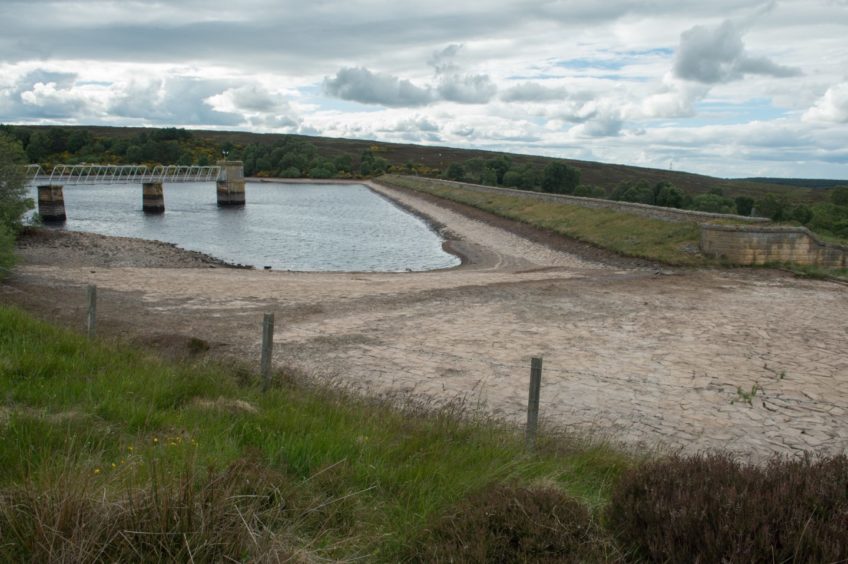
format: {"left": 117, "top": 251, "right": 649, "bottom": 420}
{"left": 0, "top": 308, "right": 848, "bottom": 562}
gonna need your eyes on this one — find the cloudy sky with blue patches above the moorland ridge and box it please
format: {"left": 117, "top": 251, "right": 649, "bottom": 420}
{"left": 0, "top": 0, "right": 848, "bottom": 179}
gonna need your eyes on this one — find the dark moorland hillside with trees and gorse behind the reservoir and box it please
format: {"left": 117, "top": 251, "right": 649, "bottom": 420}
{"left": 0, "top": 126, "right": 848, "bottom": 239}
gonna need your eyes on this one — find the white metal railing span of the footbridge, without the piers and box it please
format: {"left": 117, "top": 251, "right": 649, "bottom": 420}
{"left": 27, "top": 164, "right": 221, "bottom": 185}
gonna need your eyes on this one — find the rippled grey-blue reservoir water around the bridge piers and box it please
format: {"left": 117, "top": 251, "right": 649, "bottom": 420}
{"left": 33, "top": 183, "right": 460, "bottom": 272}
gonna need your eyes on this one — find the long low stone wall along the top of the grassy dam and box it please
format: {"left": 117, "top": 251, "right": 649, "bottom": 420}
{"left": 398, "top": 178, "right": 771, "bottom": 227}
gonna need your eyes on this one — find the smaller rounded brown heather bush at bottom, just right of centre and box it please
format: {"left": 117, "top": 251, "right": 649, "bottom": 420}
{"left": 409, "top": 485, "right": 602, "bottom": 562}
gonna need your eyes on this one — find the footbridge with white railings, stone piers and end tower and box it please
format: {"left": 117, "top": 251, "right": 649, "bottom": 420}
{"left": 27, "top": 161, "right": 244, "bottom": 223}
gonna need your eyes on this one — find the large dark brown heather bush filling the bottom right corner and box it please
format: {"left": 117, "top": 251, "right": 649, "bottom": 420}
{"left": 607, "top": 454, "right": 848, "bottom": 562}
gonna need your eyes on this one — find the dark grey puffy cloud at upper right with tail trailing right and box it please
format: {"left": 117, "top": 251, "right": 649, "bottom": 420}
{"left": 673, "top": 20, "right": 801, "bottom": 84}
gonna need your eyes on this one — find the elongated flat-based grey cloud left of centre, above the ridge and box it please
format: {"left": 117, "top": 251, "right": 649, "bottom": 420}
{"left": 324, "top": 67, "right": 433, "bottom": 107}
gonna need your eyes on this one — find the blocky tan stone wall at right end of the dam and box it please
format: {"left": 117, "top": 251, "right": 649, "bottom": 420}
{"left": 701, "top": 224, "right": 848, "bottom": 268}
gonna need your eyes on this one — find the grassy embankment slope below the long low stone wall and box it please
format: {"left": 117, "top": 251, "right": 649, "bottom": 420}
{"left": 379, "top": 176, "right": 711, "bottom": 266}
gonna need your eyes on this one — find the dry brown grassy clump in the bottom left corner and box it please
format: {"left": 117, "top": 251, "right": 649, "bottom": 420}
{"left": 0, "top": 461, "right": 292, "bottom": 562}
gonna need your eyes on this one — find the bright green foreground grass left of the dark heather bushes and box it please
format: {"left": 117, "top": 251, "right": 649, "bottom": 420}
{"left": 0, "top": 308, "right": 631, "bottom": 561}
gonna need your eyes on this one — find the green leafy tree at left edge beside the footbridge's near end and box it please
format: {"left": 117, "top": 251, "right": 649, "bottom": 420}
{"left": 0, "top": 131, "right": 33, "bottom": 278}
